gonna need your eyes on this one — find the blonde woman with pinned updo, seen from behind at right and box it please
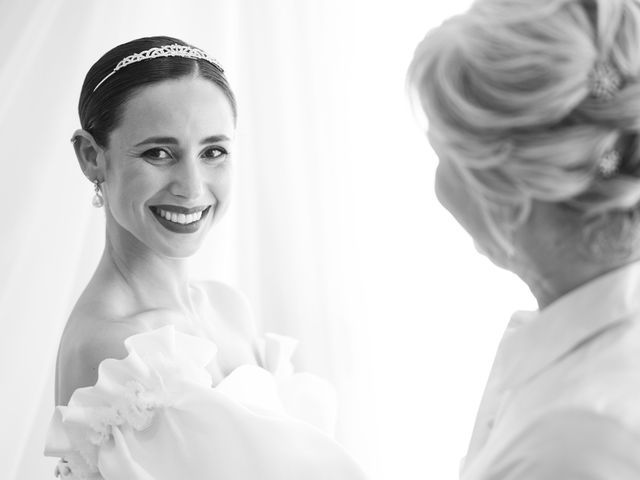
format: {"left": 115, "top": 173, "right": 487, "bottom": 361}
{"left": 408, "top": 0, "right": 640, "bottom": 480}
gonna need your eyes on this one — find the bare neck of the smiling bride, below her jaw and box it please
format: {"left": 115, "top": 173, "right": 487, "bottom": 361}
{"left": 99, "top": 223, "right": 192, "bottom": 313}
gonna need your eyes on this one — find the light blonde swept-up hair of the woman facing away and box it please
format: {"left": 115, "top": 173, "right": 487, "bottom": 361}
{"left": 407, "top": 0, "right": 640, "bottom": 255}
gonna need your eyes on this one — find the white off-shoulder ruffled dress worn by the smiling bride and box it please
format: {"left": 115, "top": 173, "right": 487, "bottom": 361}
{"left": 45, "top": 326, "right": 365, "bottom": 480}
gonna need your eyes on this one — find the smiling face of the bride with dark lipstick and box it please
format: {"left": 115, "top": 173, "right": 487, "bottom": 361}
{"left": 102, "top": 77, "right": 235, "bottom": 258}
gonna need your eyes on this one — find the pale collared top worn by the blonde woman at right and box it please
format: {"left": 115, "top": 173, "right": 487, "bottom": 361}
{"left": 461, "top": 262, "right": 640, "bottom": 480}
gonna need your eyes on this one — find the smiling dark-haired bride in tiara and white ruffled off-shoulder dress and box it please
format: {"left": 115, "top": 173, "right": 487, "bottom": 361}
{"left": 45, "top": 37, "right": 364, "bottom": 480}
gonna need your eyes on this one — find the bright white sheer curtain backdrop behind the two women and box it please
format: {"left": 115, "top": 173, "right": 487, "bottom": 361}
{"left": 0, "top": 0, "right": 531, "bottom": 480}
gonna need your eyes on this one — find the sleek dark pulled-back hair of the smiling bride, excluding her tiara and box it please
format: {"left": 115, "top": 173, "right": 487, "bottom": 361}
{"left": 78, "top": 37, "right": 237, "bottom": 147}
